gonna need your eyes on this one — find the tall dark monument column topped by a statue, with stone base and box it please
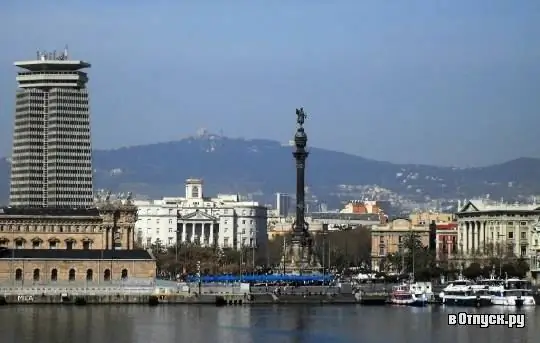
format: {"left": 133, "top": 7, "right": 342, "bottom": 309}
{"left": 282, "top": 108, "right": 320, "bottom": 274}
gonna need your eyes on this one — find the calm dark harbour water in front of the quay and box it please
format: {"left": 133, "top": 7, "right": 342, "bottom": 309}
{"left": 0, "top": 305, "right": 540, "bottom": 343}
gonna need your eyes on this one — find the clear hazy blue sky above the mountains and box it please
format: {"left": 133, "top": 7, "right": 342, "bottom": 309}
{"left": 0, "top": 0, "right": 540, "bottom": 167}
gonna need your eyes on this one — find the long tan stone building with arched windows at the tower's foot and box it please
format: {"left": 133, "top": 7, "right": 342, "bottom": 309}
{"left": 0, "top": 200, "right": 156, "bottom": 285}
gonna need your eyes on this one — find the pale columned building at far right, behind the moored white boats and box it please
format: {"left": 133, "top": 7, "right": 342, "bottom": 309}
{"left": 456, "top": 199, "right": 540, "bottom": 270}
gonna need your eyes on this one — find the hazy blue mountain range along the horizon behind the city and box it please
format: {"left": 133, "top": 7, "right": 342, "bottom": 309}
{"left": 0, "top": 134, "right": 540, "bottom": 210}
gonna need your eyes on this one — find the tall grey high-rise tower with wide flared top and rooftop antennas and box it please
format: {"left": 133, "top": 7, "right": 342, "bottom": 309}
{"left": 9, "top": 49, "right": 93, "bottom": 208}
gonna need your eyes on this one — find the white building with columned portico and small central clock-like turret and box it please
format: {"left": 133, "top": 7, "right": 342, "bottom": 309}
{"left": 135, "top": 179, "right": 267, "bottom": 249}
